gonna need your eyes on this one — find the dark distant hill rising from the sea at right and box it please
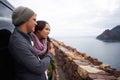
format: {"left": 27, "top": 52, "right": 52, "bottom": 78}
{"left": 97, "top": 25, "right": 120, "bottom": 42}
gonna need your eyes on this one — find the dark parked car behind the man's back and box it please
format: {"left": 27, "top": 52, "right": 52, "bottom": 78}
{"left": 0, "top": 0, "right": 14, "bottom": 80}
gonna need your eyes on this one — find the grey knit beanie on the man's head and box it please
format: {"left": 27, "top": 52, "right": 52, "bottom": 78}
{"left": 12, "top": 6, "right": 34, "bottom": 27}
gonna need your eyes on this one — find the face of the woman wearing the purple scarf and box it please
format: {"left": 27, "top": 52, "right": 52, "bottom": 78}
{"left": 39, "top": 24, "right": 50, "bottom": 38}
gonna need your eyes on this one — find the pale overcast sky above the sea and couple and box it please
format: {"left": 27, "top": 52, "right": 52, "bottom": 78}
{"left": 8, "top": 0, "right": 120, "bottom": 37}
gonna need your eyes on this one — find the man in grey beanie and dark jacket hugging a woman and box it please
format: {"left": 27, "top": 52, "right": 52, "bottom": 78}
{"left": 9, "top": 6, "right": 54, "bottom": 80}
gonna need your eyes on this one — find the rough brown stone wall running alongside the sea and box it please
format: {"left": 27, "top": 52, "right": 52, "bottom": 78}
{"left": 52, "top": 39, "right": 120, "bottom": 80}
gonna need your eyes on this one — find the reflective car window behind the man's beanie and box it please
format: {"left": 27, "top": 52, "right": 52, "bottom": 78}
{"left": 0, "top": 2, "right": 14, "bottom": 32}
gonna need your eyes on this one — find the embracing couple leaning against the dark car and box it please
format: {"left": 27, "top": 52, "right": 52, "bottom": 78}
{"left": 9, "top": 6, "right": 58, "bottom": 80}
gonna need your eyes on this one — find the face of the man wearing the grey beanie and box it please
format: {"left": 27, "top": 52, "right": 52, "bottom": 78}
{"left": 26, "top": 14, "right": 37, "bottom": 33}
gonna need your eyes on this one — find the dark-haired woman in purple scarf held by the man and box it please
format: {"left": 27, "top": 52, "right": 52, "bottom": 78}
{"left": 31, "top": 21, "right": 59, "bottom": 80}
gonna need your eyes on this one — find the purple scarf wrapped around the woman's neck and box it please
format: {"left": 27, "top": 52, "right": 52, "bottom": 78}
{"left": 30, "top": 33, "right": 47, "bottom": 55}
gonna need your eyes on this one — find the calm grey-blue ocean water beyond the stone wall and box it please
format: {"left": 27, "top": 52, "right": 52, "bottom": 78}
{"left": 55, "top": 37, "right": 120, "bottom": 70}
